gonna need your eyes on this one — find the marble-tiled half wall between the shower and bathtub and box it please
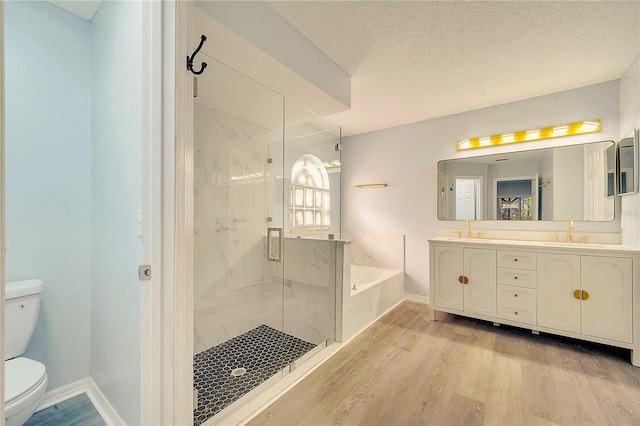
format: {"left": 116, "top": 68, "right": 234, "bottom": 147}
{"left": 267, "top": 238, "right": 344, "bottom": 344}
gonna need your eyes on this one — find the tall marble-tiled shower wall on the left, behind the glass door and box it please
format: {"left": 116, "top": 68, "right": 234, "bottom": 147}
{"left": 194, "top": 105, "right": 281, "bottom": 353}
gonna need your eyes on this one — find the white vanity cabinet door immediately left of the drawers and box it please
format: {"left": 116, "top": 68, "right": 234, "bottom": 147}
{"left": 464, "top": 248, "right": 496, "bottom": 317}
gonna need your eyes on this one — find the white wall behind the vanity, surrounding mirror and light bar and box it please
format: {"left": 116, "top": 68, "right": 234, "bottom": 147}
{"left": 342, "top": 80, "right": 620, "bottom": 296}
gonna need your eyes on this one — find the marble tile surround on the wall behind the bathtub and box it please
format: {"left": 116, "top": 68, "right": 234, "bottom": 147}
{"left": 342, "top": 232, "right": 404, "bottom": 271}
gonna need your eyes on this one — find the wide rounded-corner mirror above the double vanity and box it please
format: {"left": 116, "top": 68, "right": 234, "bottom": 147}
{"left": 438, "top": 141, "right": 617, "bottom": 221}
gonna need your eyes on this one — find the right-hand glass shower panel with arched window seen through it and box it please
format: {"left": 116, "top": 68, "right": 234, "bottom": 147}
{"left": 283, "top": 104, "right": 342, "bottom": 352}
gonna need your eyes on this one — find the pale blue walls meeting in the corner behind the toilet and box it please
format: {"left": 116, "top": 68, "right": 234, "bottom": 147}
{"left": 5, "top": 1, "right": 142, "bottom": 424}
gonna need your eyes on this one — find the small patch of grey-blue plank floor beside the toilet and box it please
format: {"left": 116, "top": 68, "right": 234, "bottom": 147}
{"left": 24, "top": 393, "right": 106, "bottom": 426}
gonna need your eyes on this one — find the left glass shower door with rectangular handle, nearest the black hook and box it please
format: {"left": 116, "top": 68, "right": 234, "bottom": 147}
{"left": 193, "top": 55, "right": 285, "bottom": 425}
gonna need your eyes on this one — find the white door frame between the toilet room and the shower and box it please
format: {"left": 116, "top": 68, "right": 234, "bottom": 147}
{"left": 140, "top": 2, "right": 175, "bottom": 424}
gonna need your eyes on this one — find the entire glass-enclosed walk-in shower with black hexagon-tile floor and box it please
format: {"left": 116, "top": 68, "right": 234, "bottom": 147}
{"left": 194, "top": 55, "right": 341, "bottom": 425}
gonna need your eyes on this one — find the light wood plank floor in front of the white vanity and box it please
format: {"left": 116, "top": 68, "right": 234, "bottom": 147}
{"left": 249, "top": 301, "right": 640, "bottom": 425}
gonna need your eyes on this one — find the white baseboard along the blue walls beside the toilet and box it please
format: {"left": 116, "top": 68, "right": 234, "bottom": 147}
{"left": 36, "top": 377, "right": 125, "bottom": 426}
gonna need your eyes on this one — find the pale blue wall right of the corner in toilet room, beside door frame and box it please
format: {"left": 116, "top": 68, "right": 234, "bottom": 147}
{"left": 91, "top": 1, "right": 142, "bottom": 425}
